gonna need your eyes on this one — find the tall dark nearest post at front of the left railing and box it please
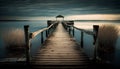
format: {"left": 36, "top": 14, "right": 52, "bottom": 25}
{"left": 24, "top": 25, "right": 30, "bottom": 64}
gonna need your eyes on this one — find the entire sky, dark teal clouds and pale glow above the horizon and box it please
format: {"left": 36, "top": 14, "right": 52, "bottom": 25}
{"left": 0, "top": 0, "right": 120, "bottom": 20}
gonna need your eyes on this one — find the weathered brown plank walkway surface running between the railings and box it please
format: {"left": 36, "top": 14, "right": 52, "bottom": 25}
{"left": 31, "top": 23, "right": 91, "bottom": 68}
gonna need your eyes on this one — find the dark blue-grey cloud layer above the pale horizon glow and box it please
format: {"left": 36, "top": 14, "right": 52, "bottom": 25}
{"left": 0, "top": 0, "right": 120, "bottom": 16}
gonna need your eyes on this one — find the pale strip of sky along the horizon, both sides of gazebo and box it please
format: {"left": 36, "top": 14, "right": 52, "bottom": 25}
{"left": 0, "top": 14, "right": 120, "bottom": 20}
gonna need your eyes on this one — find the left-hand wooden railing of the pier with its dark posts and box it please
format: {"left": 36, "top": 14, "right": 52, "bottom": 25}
{"left": 24, "top": 22, "right": 58, "bottom": 64}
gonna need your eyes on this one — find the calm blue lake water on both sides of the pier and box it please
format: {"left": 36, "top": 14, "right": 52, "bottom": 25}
{"left": 0, "top": 21, "right": 120, "bottom": 66}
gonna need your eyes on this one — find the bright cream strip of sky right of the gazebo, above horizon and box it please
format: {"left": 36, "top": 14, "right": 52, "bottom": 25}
{"left": 65, "top": 14, "right": 120, "bottom": 20}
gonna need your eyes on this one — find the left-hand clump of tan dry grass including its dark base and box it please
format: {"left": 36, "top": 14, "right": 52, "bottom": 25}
{"left": 2, "top": 29, "right": 25, "bottom": 57}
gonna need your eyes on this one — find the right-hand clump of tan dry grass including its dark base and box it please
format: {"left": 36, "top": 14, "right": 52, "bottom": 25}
{"left": 97, "top": 25, "right": 119, "bottom": 62}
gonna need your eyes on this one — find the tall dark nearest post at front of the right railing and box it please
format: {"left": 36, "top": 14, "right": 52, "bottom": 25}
{"left": 93, "top": 25, "right": 99, "bottom": 60}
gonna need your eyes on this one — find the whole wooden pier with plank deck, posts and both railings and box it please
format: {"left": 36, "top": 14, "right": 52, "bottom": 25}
{"left": 0, "top": 21, "right": 99, "bottom": 69}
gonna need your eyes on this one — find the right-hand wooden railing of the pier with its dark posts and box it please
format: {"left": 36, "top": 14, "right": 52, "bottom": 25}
{"left": 62, "top": 21, "right": 99, "bottom": 60}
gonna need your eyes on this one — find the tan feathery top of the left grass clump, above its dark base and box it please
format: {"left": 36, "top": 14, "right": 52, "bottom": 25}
{"left": 3, "top": 29, "right": 25, "bottom": 50}
